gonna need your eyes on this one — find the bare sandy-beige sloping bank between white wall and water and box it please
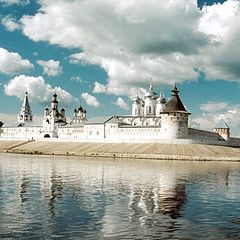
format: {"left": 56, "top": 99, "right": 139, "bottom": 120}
{"left": 0, "top": 140, "right": 240, "bottom": 162}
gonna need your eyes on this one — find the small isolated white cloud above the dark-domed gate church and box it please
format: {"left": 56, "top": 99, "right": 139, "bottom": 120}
{"left": 37, "top": 59, "right": 62, "bottom": 77}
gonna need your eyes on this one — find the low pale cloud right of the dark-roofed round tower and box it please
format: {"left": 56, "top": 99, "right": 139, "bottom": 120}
{"left": 191, "top": 102, "right": 240, "bottom": 135}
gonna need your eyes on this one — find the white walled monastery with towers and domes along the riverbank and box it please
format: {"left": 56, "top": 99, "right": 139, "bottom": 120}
{"left": 1, "top": 84, "right": 240, "bottom": 146}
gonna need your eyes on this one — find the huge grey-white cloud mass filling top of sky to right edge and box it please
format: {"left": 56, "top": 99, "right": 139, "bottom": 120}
{"left": 17, "top": 0, "right": 240, "bottom": 95}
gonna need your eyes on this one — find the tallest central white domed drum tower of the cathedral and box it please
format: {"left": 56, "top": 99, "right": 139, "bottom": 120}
{"left": 144, "top": 83, "right": 157, "bottom": 116}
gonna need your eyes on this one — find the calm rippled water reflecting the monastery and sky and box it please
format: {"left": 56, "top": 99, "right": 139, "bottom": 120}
{"left": 0, "top": 154, "right": 240, "bottom": 239}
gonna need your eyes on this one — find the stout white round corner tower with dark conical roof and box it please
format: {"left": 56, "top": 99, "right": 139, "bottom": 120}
{"left": 161, "top": 85, "right": 190, "bottom": 139}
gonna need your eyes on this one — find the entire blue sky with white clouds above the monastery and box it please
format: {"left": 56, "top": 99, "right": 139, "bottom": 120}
{"left": 0, "top": 0, "right": 240, "bottom": 135}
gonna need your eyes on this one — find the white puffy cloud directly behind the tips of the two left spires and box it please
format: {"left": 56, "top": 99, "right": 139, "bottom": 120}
{"left": 4, "top": 75, "right": 76, "bottom": 106}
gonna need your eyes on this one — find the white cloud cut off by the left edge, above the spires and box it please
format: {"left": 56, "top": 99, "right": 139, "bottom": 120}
{"left": 0, "top": 48, "right": 34, "bottom": 75}
